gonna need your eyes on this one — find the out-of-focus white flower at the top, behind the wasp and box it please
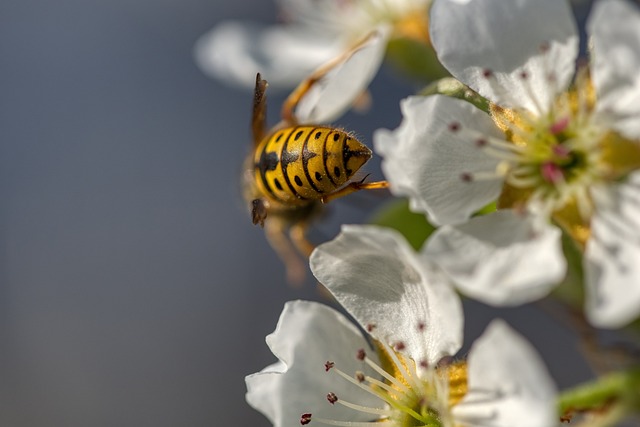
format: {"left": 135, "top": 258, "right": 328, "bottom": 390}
{"left": 195, "top": 0, "right": 430, "bottom": 88}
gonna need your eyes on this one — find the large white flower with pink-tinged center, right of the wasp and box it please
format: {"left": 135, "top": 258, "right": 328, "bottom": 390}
{"left": 374, "top": 0, "right": 640, "bottom": 328}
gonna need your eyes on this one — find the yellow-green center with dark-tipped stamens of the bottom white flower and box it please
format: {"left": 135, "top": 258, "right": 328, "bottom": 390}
{"left": 300, "top": 332, "right": 467, "bottom": 427}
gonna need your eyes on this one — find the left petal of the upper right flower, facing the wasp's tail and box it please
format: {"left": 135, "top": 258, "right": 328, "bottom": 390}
{"left": 373, "top": 95, "right": 504, "bottom": 225}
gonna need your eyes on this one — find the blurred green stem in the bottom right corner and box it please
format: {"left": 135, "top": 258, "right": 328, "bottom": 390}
{"left": 558, "top": 369, "right": 640, "bottom": 425}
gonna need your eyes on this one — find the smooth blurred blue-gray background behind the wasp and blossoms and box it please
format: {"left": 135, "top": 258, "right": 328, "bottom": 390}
{"left": 0, "top": 0, "right": 589, "bottom": 427}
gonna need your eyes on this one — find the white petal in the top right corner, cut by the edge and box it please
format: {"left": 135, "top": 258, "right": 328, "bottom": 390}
{"left": 587, "top": 0, "right": 640, "bottom": 139}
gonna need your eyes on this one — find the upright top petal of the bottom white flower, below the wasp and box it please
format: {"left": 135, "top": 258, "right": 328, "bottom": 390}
{"left": 310, "top": 226, "right": 463, "bottom": 363}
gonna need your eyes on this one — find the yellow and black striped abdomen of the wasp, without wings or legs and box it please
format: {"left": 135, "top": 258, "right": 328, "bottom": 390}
{"left": 254, "top": 126, "right": 371, "bottom": 206}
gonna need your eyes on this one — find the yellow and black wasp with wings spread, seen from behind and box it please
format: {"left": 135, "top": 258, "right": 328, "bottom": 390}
{"left": 243, "top": 32, "right": 388, "bottom": 283}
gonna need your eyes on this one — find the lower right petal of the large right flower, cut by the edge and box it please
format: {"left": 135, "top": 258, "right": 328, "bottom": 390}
{"left": 583, "top": 172, "right": 640, "bottom": 328}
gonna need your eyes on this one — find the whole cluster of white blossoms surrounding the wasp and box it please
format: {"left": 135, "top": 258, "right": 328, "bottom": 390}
{"left": 197, "top": 0, "right": 640, "bottom": 427}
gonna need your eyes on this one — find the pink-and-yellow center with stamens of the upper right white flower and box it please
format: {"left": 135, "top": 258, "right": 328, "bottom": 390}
{"left": 449, "top": 68, "right": 640, "bottom": 244}
